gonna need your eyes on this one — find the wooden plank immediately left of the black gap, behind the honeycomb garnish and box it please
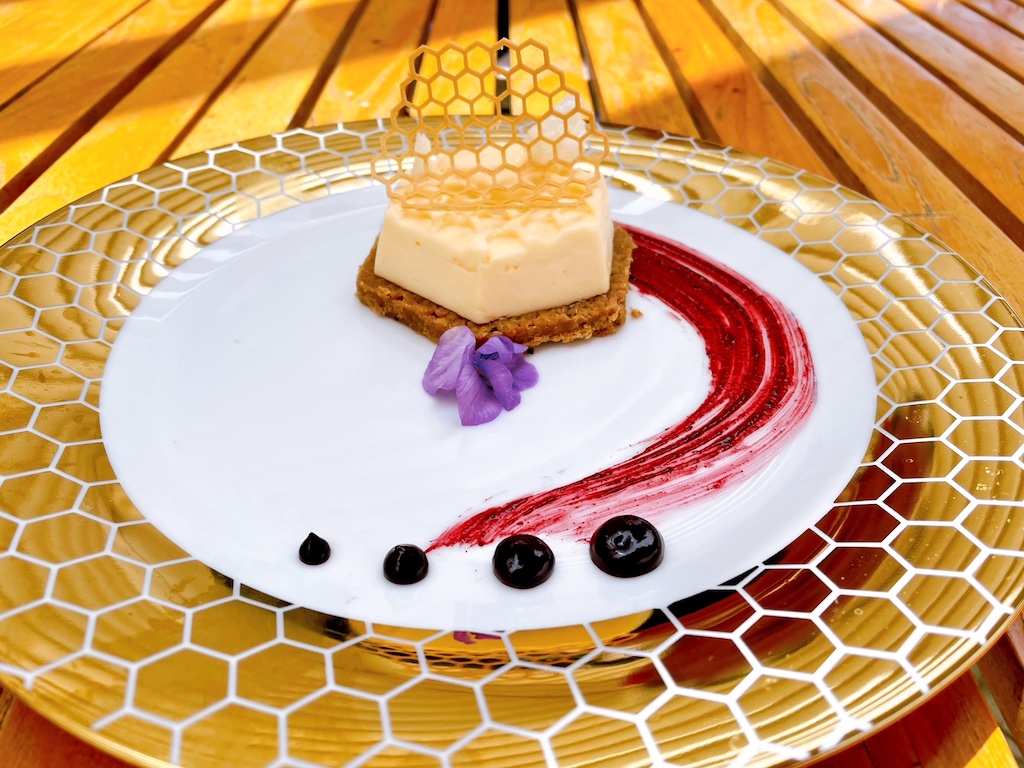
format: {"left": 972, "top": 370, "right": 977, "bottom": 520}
{"left": 414, "top": 0, "right": 498, "bottom": 115}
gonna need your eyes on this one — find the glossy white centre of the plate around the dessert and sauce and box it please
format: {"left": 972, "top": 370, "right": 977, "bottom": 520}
{"left": 101, "top": 187, "right": 876, "bottom": 631}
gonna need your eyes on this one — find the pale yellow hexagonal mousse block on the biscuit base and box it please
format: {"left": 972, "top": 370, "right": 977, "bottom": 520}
{"left": 375, "top": 179, "right": 612, "bottom": 323}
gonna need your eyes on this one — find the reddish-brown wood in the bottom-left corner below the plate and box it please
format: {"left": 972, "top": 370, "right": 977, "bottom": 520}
{"left": 0, "top": 688, "right": 128, "bottom": 768}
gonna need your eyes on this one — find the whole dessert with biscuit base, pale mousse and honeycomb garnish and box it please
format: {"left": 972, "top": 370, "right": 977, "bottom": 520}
{"left": 356, "top": 41, "right": 633, "bottom": 346}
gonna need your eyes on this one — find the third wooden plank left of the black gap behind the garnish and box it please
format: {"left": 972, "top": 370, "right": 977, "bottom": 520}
{"left": 173, "top": 0, "right": 358, "bottom": 156}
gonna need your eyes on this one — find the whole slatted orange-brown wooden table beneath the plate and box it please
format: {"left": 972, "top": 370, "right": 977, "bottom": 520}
{"left": 0, "top": 0, "right": 1024, "bottom": 768}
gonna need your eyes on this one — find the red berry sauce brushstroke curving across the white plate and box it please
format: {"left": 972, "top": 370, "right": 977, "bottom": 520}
{"left": 430, "top": 227, "right": 816, "bottom": 550}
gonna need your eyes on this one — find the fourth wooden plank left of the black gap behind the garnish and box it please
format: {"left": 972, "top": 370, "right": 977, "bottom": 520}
{"left": 0, "top": 0, "right": 287, "bottom": 242}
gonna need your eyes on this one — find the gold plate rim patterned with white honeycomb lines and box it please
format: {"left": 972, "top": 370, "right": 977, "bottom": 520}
{"left": 0, "top": 123, "right": 1024, "bottom": 767}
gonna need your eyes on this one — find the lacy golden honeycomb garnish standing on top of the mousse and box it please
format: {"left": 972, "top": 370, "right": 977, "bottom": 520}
{"left": 373, "top": 40, "right": 608, "bottom": 210}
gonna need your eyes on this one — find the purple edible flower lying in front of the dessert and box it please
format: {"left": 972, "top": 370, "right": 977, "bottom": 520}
{"left": 423, "top": 326, "right": 538, "bottom": 427}
